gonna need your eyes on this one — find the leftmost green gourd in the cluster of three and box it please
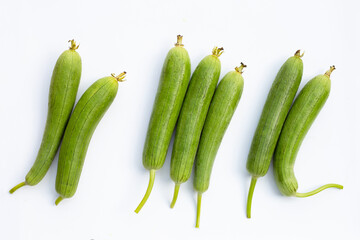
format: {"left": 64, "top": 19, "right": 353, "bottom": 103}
{"left": 135, "top": 35, "right": 191, "bottom": 213}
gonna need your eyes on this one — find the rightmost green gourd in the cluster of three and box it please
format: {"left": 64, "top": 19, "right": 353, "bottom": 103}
{"left": 194, "top": 63, "right": 246, "bottom": 227}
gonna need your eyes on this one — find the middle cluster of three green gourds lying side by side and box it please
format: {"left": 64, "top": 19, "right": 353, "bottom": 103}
{"left": 135, "top": 35, "right": 246, "bottom": 227}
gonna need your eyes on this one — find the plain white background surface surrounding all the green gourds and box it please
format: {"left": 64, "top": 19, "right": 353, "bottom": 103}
{"left": 0, "top": 0, "right": 360, "bottom": 240}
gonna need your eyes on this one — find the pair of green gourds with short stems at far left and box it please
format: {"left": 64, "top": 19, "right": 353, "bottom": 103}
{"left": 10, "top": 40, "right": 126, "bottom": 205}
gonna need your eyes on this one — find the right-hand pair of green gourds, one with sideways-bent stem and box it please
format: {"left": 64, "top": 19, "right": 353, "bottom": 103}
{"left": 246, "top": 50, "right": 343, "bottom": 218}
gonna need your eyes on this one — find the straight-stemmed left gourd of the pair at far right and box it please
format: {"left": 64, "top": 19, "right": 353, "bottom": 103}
{"left": 246, "top": 50, "right": 303, "bottom": 218}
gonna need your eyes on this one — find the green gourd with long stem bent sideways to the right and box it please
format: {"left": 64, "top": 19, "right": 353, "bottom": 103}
{"left": 274, "top": 66, "right": 343, "bottom": 197}
